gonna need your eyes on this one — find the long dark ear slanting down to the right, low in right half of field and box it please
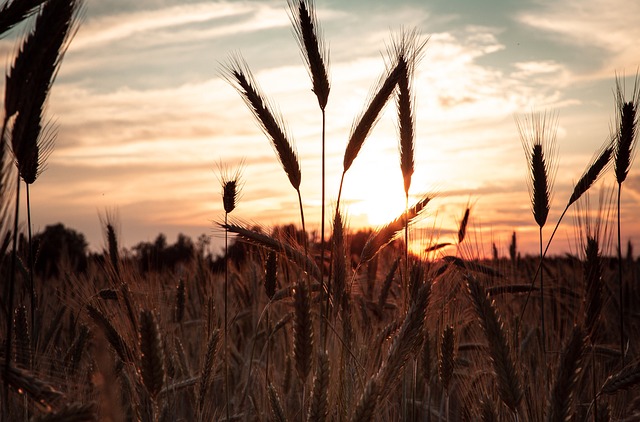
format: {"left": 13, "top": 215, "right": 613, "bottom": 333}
{"left": 466, "top": 276, "right": 522, "bottom": 413}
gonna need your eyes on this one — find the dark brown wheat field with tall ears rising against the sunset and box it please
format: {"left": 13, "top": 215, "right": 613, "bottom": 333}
{"left": 0, "top": 0, "right": 640, "bottom": 421}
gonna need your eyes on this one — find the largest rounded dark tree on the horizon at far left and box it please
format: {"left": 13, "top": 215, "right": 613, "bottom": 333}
{"left": 33, "top": 223, "right": 87, "bottom": 277}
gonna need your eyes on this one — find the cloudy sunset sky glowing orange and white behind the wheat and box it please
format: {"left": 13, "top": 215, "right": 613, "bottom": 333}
{"left": 0, "top": 0, "right": 640, "bottom": 255}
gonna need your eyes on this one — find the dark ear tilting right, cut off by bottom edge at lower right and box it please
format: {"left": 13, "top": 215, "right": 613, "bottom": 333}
{"left": 547, "top": 326, "right": 585, "bottom": 422}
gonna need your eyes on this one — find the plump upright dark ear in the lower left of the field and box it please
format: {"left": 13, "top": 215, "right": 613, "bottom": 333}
{"left": 139, "top": 310, "right": 165, "bottom": 399}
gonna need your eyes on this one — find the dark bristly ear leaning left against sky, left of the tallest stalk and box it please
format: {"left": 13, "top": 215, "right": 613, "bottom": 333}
{"left": 223, "top": 56, "right": 302, "bottom": 190}
